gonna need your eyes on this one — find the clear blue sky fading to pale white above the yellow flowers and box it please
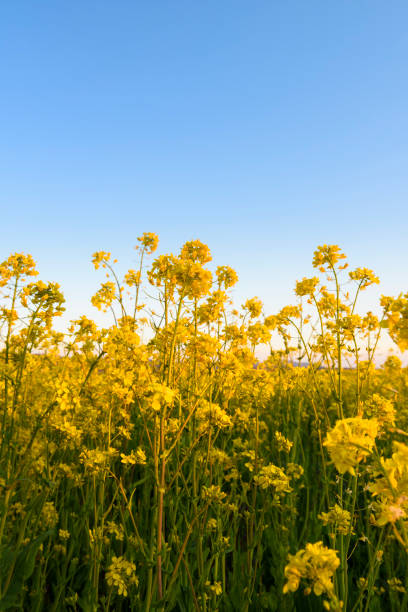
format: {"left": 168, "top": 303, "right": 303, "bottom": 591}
{"left": 0, "top": 0, "right": 408, "bottom": 358}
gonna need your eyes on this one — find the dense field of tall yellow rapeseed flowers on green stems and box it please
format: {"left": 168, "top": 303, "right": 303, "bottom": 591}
{"left": 0, "top": 233, "right": 408, "bottom": 612}
